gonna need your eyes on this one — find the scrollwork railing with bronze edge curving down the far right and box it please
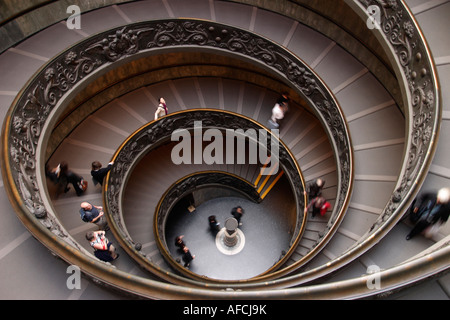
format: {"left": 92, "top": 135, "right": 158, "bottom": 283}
{"left": 346, "top": 0, "right": 442, "bottom": 241}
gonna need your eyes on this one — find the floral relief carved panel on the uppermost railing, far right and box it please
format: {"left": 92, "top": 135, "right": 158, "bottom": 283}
{"left": 359, "top": 0, "right": 439, "bottom": 229}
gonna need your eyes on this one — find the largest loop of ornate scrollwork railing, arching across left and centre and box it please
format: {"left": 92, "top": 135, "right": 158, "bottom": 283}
{"left": 2, "top": 19, "right": 353, "bottom": 296}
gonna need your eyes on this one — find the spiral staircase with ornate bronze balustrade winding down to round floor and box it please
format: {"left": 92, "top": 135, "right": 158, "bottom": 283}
{"left": 0, "top": 0, "right": 450, "bottom": 300}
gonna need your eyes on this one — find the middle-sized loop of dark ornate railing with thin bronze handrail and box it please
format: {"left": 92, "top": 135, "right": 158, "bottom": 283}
{"left": 104, "top": 109, "right": 306, "bottom": 286}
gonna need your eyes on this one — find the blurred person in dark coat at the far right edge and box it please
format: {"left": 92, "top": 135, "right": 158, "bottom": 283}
{"left": 406, "top": 188, "right": 450, "bottom": 240}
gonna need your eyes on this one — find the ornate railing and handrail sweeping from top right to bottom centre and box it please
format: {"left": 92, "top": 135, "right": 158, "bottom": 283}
{"left": 246, "top": 0, "right": 450, "bottom": 295}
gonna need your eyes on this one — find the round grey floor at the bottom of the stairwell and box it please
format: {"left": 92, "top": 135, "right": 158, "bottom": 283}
{"left": 166, "top": 178, "right": 293, "bottom": 280}
